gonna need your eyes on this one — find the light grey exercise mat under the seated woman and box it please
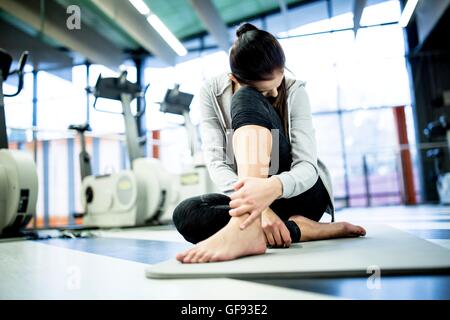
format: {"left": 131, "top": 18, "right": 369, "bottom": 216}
{"left": 146, "top": 225, "right": 450, "bottom": 279}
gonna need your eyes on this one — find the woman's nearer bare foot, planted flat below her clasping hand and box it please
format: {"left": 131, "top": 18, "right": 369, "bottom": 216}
{"left": 176, "top": 215, "right": 266, "bottom": 263}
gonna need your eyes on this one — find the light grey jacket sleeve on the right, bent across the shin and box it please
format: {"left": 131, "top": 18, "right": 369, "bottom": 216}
{"left": 276, "top": 85, "right": 319, "bottom": 198}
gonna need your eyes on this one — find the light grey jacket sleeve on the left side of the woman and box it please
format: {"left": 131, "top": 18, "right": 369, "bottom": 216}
{"left": 198, "top": 82, "right": 238, "bottom": 191}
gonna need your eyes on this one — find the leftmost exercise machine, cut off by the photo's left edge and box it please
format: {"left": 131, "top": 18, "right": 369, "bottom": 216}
{"left": 0, "top": 49, "right": 38, "bottom": 236}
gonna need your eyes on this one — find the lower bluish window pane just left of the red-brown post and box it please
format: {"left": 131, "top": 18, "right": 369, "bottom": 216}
{"left": 343, "top": 108, "right": 401, "bottom": 206}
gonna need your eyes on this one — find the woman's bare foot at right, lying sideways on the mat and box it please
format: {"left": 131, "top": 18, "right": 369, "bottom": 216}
{"left": 289, "top": 216, "right": 366, "bottom": 241}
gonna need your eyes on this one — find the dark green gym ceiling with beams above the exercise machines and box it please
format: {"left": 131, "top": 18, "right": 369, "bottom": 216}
{"left": 0, "top": 0, "right": 310, "bottom": 68}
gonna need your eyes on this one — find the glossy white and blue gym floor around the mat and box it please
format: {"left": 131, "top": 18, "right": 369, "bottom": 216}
{"left": 0, "top": 206, "right": 450, "bottom": 300}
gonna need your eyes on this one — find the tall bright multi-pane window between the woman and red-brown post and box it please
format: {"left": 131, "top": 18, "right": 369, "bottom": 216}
{"left": 280, "top": 0, "right": 418, "bottom": 206}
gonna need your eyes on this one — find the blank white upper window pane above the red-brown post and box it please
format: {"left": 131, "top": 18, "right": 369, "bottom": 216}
{"left": 335, "top": 26, "right": 411, "bottom": 109}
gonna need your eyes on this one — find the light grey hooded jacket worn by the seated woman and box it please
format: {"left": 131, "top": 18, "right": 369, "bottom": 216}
{"left": 197, "top": 73, "right": 334, "bottom": 217}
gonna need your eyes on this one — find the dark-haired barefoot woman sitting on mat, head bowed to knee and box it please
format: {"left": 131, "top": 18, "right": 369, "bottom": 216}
{"left": 173, "top": 23, "right": 365, "bottom": 263}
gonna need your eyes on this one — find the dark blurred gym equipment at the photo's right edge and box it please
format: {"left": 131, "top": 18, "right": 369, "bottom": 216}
{"left": 424, "top": 116, "right": 450, "bottom": 205}
